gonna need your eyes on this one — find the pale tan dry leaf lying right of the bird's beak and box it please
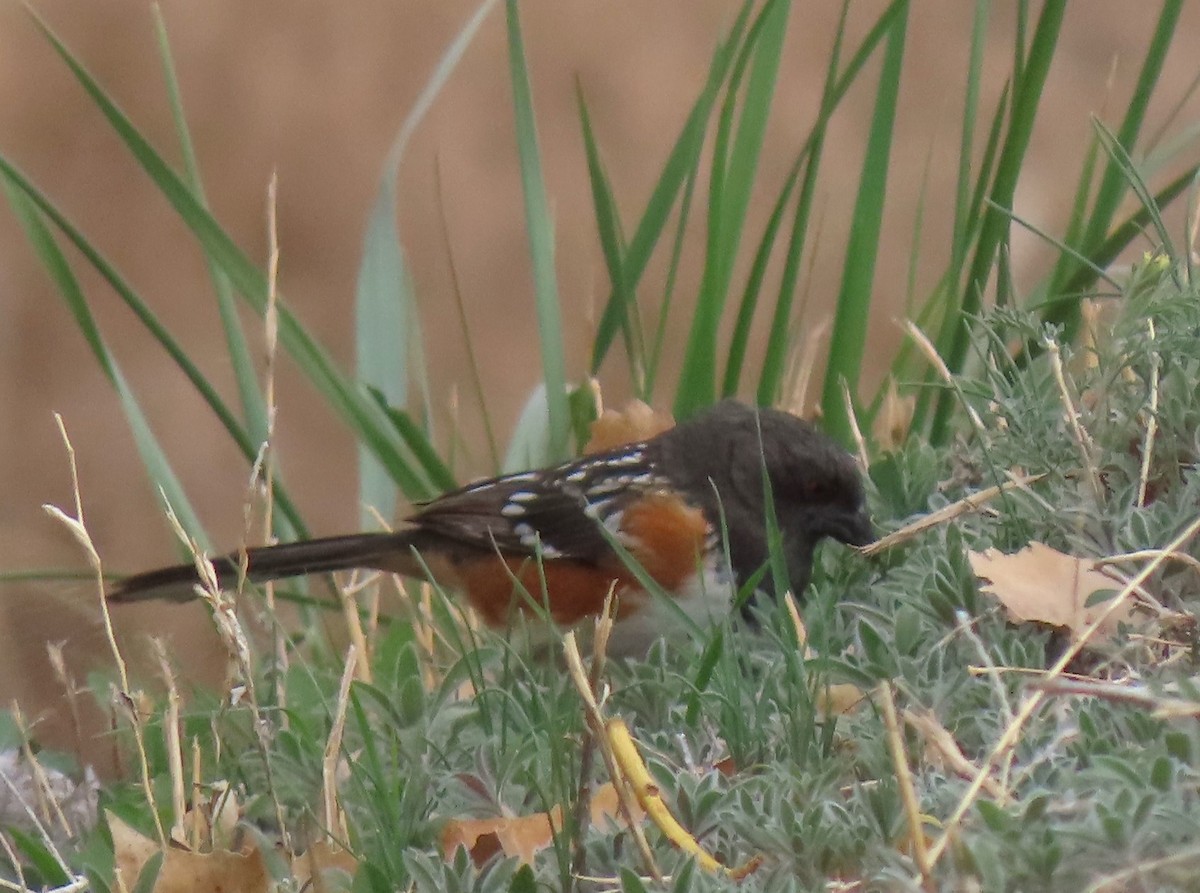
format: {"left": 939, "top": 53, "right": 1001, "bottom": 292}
{"left": 967, "top": 543, "right": 1133, "bottom": 643}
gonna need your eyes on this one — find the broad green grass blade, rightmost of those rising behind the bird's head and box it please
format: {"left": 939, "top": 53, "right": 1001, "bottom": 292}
{"left": 821, "top": 4, "right": 908, "bottom": 443}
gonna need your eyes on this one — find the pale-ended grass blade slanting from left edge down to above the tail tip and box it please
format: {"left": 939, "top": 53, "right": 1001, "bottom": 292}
{"left": 4, "top": 179, "right": 208, "bottom": 549}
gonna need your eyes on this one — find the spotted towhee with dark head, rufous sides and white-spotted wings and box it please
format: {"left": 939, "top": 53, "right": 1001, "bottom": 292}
{"left": 109, "top": 400, "right": 871, "bottom": 653}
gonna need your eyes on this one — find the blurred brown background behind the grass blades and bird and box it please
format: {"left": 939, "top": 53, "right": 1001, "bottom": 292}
{"left": 0, "top": 0, "right": 1200, "bottom": 758}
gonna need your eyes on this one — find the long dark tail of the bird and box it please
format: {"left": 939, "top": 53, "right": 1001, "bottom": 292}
{"left": 108, "top": 532, "right": 420, "bottom": 601}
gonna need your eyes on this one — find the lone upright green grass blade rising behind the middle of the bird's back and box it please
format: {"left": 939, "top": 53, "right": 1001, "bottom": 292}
{"left": 508, "top": 0, "right": 571, "bottom": 460}
